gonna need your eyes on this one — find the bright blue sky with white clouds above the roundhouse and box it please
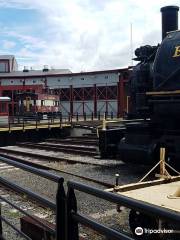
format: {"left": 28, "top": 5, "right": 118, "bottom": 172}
{"left": 0, "top": 0, "right": 180, "bottom": 72}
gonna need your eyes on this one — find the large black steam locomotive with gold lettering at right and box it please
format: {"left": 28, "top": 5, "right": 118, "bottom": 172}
{"left": 99, "top": 6, "right": 180, "bottom": 169}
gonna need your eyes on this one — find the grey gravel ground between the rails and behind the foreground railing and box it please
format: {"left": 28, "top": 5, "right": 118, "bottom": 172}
{"left": 1, "top": 131, "right": 153, "bottom": 240}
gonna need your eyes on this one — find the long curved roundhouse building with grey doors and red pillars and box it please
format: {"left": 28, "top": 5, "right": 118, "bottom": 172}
{"left": 0, "top": 56, "right": 129, "bottom": 116}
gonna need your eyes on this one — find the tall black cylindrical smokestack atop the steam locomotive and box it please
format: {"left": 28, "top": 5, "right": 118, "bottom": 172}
{"left": 161, "top": 6, "right": 179, "bottom": 39}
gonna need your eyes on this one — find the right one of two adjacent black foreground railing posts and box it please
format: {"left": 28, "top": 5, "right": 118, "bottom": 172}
{"left": 66, "top": 187, "right": 79, "bottom": 240}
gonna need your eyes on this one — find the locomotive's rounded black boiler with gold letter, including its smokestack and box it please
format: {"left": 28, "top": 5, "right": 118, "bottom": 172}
{"left": 153, "top": 6, "right": 180, "bottom": 91}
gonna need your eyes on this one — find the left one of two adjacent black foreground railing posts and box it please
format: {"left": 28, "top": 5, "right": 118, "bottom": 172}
{"left": 56, "top": 179, "right": 66, "bottom": 240}
